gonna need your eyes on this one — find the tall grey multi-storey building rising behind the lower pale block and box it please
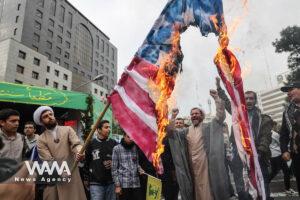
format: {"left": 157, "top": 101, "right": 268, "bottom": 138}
{"left": 0, "top": 0, "right": 117, "bottom": 96}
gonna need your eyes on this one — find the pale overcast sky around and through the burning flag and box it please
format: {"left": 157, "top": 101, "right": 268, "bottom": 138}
{"left": 69, "top": 0, "right": 300, "bottom": 115}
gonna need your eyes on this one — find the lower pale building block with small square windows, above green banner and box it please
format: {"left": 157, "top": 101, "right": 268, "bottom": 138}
{"left": 0, "top": 39, "right": 72, "bottom": 90}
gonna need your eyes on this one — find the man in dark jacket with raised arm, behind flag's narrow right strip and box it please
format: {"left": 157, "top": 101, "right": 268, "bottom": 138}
{"left": 216, "top": 78, "right": 273, "bottom": 200}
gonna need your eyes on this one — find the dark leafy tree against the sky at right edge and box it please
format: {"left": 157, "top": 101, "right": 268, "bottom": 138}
{"left": 272, "top": 26, "right": 300, "bottom": 83}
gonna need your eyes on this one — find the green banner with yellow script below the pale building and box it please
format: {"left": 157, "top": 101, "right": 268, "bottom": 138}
{"left": 0, "top": 82, "right": 87, "bottom": 110}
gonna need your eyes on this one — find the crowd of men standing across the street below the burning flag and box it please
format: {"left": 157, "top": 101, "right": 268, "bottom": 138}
{"left": 0, "top": 78, "right": 300, "bottom": 200}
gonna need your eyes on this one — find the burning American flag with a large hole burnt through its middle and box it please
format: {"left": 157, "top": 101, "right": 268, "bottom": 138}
{"left": 109, "top": 0, "right": 260, "bottom": 196}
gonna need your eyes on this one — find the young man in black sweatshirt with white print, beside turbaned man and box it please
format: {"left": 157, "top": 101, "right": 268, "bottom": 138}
{"left": 85, "top": 120, "right": 117, "bottom": 200}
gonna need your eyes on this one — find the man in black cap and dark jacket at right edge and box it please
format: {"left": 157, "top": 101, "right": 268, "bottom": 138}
{"left": 280, "top": 82, "right": 300, "bottom": 196}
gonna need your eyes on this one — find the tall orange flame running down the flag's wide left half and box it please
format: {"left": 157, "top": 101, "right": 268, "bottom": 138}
{"left": 148, "top": 26, "right": 181, "bottom": 172}
